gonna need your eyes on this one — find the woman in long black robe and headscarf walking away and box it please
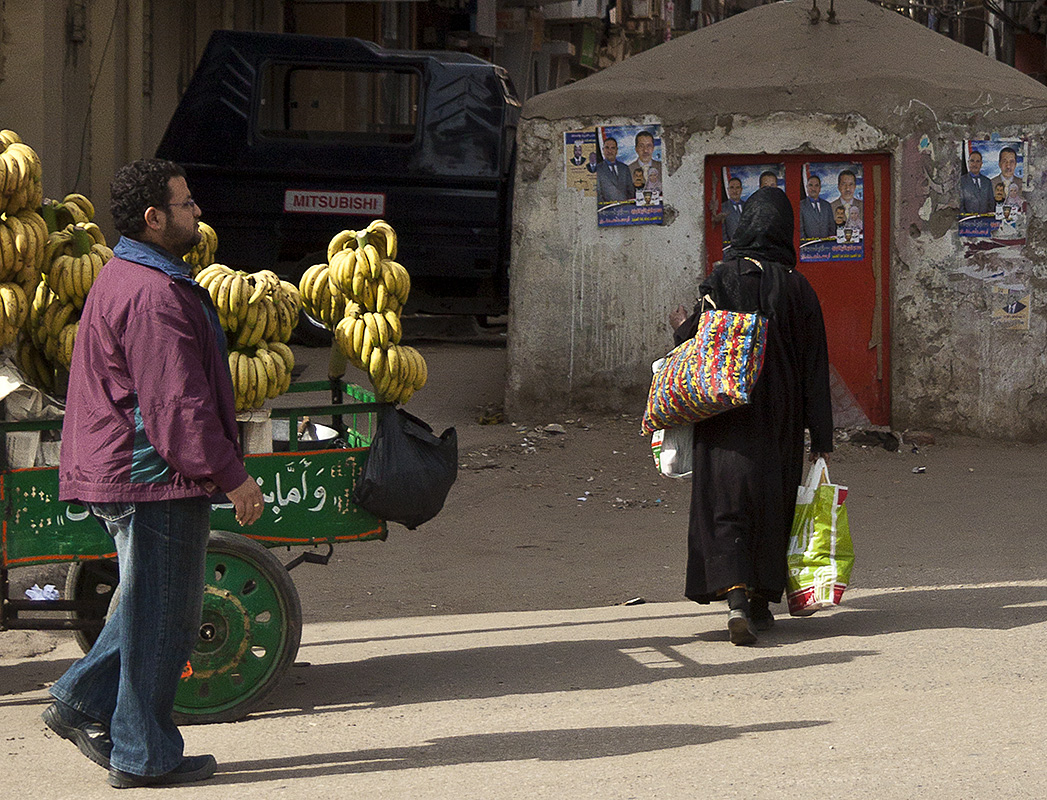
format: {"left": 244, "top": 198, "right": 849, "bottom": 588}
{"left": 669, "top": 187, "right": 832, "bottom": 644}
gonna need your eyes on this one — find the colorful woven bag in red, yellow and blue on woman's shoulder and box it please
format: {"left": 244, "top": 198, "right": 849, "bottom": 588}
{"left": 643, "top": 309, "right": 767, "bottom": 434}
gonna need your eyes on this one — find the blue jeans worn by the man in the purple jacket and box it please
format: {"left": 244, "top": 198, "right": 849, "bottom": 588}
{"left": 51, "top": 497, "right": 210, "bottom": 775}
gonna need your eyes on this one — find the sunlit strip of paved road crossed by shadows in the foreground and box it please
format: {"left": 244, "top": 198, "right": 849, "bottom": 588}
{"left": 6, "top": 582, "right": 1047, "bottom": 800}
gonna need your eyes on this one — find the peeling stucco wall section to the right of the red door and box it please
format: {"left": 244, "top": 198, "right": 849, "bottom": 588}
{"left": 891, "top": 120, "right": 1047, "bottom": 441}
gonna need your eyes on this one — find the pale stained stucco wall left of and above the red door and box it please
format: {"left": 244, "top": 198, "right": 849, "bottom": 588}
{"left": 507, "top": 114, "right": 892, "bottom": 419}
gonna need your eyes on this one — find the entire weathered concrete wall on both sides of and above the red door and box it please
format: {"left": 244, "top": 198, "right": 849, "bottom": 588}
{"left": 506, "top": 111, "right": 1047, "bottom": 440}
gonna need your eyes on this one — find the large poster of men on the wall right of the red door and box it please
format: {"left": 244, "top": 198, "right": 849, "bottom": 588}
{"left": 956, "top": 139, "right": 1029, "bottom": 246}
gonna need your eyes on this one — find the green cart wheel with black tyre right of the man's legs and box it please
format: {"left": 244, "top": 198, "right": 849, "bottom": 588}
{"left": 175, "top": 531, "right": 302, "bottom": 724}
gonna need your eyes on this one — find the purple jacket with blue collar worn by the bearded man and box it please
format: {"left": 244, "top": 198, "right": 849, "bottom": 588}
{"left": 59, "top": 238, "right": 247, "bottom": 503}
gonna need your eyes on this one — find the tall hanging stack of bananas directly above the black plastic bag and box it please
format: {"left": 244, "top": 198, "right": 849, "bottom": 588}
{"left": 322, "top": 220, "right": 428, "bottom": 403}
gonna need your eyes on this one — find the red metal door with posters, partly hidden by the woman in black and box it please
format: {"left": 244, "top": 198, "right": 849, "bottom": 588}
{"left": 706, "top": 154, "right": 891, "bottom": 427}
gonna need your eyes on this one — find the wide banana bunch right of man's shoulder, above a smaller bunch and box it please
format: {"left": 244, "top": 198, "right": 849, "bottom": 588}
{"left": 196, "top": 264, "right": 302, "bottom": 348}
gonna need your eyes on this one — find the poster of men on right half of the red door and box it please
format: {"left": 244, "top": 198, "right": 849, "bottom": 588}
{"left": 800, "top": 161, "right": 865, "bottom": 262}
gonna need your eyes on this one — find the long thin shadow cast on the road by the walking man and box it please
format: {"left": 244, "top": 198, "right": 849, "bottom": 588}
{"left": 213, "top": 719, "right": 828, "bottom": 784}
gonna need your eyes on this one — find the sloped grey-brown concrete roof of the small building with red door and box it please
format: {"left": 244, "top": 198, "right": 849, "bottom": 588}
{"left": 524, "top": 0, "right": 1047, "bottom": 131}
